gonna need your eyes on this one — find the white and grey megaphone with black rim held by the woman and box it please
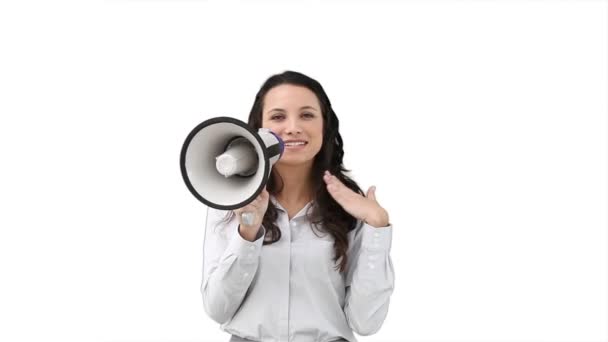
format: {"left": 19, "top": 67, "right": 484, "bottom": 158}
{"left": 180, "top": 117, "right": 285, "bottom": 224}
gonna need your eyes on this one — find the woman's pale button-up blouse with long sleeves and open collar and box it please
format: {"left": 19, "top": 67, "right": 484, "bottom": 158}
{"left": 201, "top": 195, "right": 395, "bottom": 342}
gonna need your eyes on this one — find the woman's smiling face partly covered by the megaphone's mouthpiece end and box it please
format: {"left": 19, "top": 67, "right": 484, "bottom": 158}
{"left": 262, "top": 84, "right": 323, "bottom": 165}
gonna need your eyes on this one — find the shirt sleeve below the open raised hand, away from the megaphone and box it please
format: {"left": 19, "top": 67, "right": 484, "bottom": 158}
{"left": 344, "top": 221, "right": 395, "bottom": 336}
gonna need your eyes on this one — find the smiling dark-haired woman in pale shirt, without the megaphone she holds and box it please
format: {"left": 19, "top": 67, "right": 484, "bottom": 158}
{"left": 201, "top": 71, "right": 394, "bottom": 342}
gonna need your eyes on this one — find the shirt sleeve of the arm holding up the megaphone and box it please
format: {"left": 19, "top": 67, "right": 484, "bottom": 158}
{"left": 201, "top": 208, "right": 266, "bottom": 324}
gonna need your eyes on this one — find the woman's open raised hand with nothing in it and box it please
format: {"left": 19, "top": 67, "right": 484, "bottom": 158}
{"left": 323, "top": 171, "right": 389, "bottom": 228}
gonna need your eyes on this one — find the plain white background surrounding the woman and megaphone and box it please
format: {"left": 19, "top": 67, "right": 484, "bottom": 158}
{"left": 0, "top": 0, "right": 608, "bottom": 342}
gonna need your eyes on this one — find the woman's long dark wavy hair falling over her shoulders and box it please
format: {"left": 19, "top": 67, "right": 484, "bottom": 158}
{"left": 228, "top": 71, "right": 364, "bottom": 272}
